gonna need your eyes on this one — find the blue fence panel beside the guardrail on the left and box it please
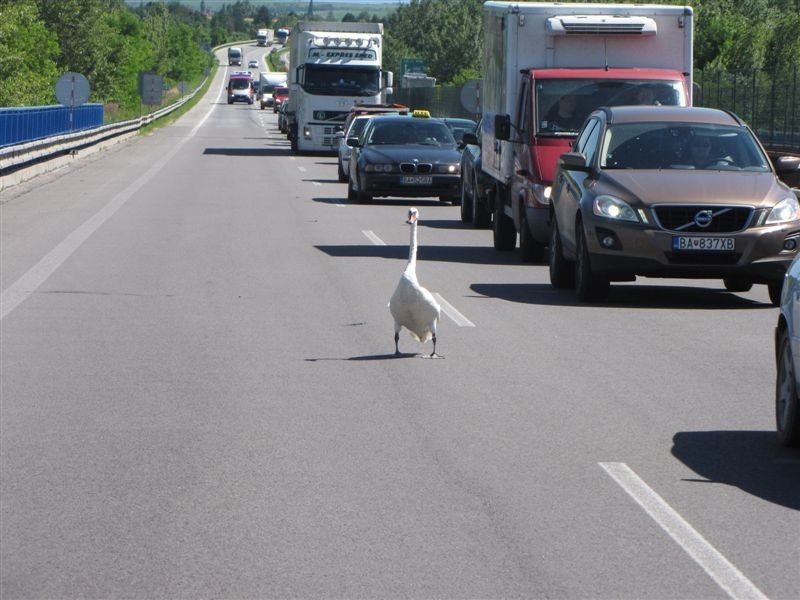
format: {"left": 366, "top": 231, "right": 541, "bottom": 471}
{"left": 0, "top": 104, "right": 103, "bottom": 146}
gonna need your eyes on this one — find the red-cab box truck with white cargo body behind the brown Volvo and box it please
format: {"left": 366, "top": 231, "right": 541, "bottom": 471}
{"left": 473, "top": 0, "right": 693, "bottom": 262}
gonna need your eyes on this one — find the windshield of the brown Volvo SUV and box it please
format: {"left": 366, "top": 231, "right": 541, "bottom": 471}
{"left": 600, "top": 122, "right": 770, "bottom": 172}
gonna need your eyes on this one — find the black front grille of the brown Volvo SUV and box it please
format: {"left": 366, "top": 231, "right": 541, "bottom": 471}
{"left": 653, "top": 204, "right": 753, "bottom": 233}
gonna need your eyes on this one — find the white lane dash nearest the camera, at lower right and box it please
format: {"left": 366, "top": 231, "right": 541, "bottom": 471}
{"left": 598, "top": 463, "right": 767, "bottom": 600}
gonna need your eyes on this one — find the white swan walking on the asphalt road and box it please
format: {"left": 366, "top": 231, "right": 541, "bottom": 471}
{"left": 389, "top": 208, "right": 442, "bottom": 358}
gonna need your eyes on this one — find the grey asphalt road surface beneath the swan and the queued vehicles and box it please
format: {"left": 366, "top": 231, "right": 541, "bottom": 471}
{"left": 0, "top": 48, "right": 800, "bottom": 600}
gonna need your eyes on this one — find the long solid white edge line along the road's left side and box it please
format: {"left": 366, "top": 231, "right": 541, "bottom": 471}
{"left": 0, "top": 78, "right": 225, "bottom": 321}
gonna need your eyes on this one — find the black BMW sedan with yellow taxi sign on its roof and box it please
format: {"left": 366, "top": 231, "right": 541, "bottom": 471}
{"left": 347, "top": 111, "right": 461, "bottom": 204}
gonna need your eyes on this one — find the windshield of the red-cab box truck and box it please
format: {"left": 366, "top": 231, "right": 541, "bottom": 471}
{"left": 535, "top": 79, "right": 685, "bottom": 136}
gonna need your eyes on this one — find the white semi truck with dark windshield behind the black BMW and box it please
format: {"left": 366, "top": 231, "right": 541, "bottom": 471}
{"left": 285, "top": 21, "right": 393, "bottom": 154}
